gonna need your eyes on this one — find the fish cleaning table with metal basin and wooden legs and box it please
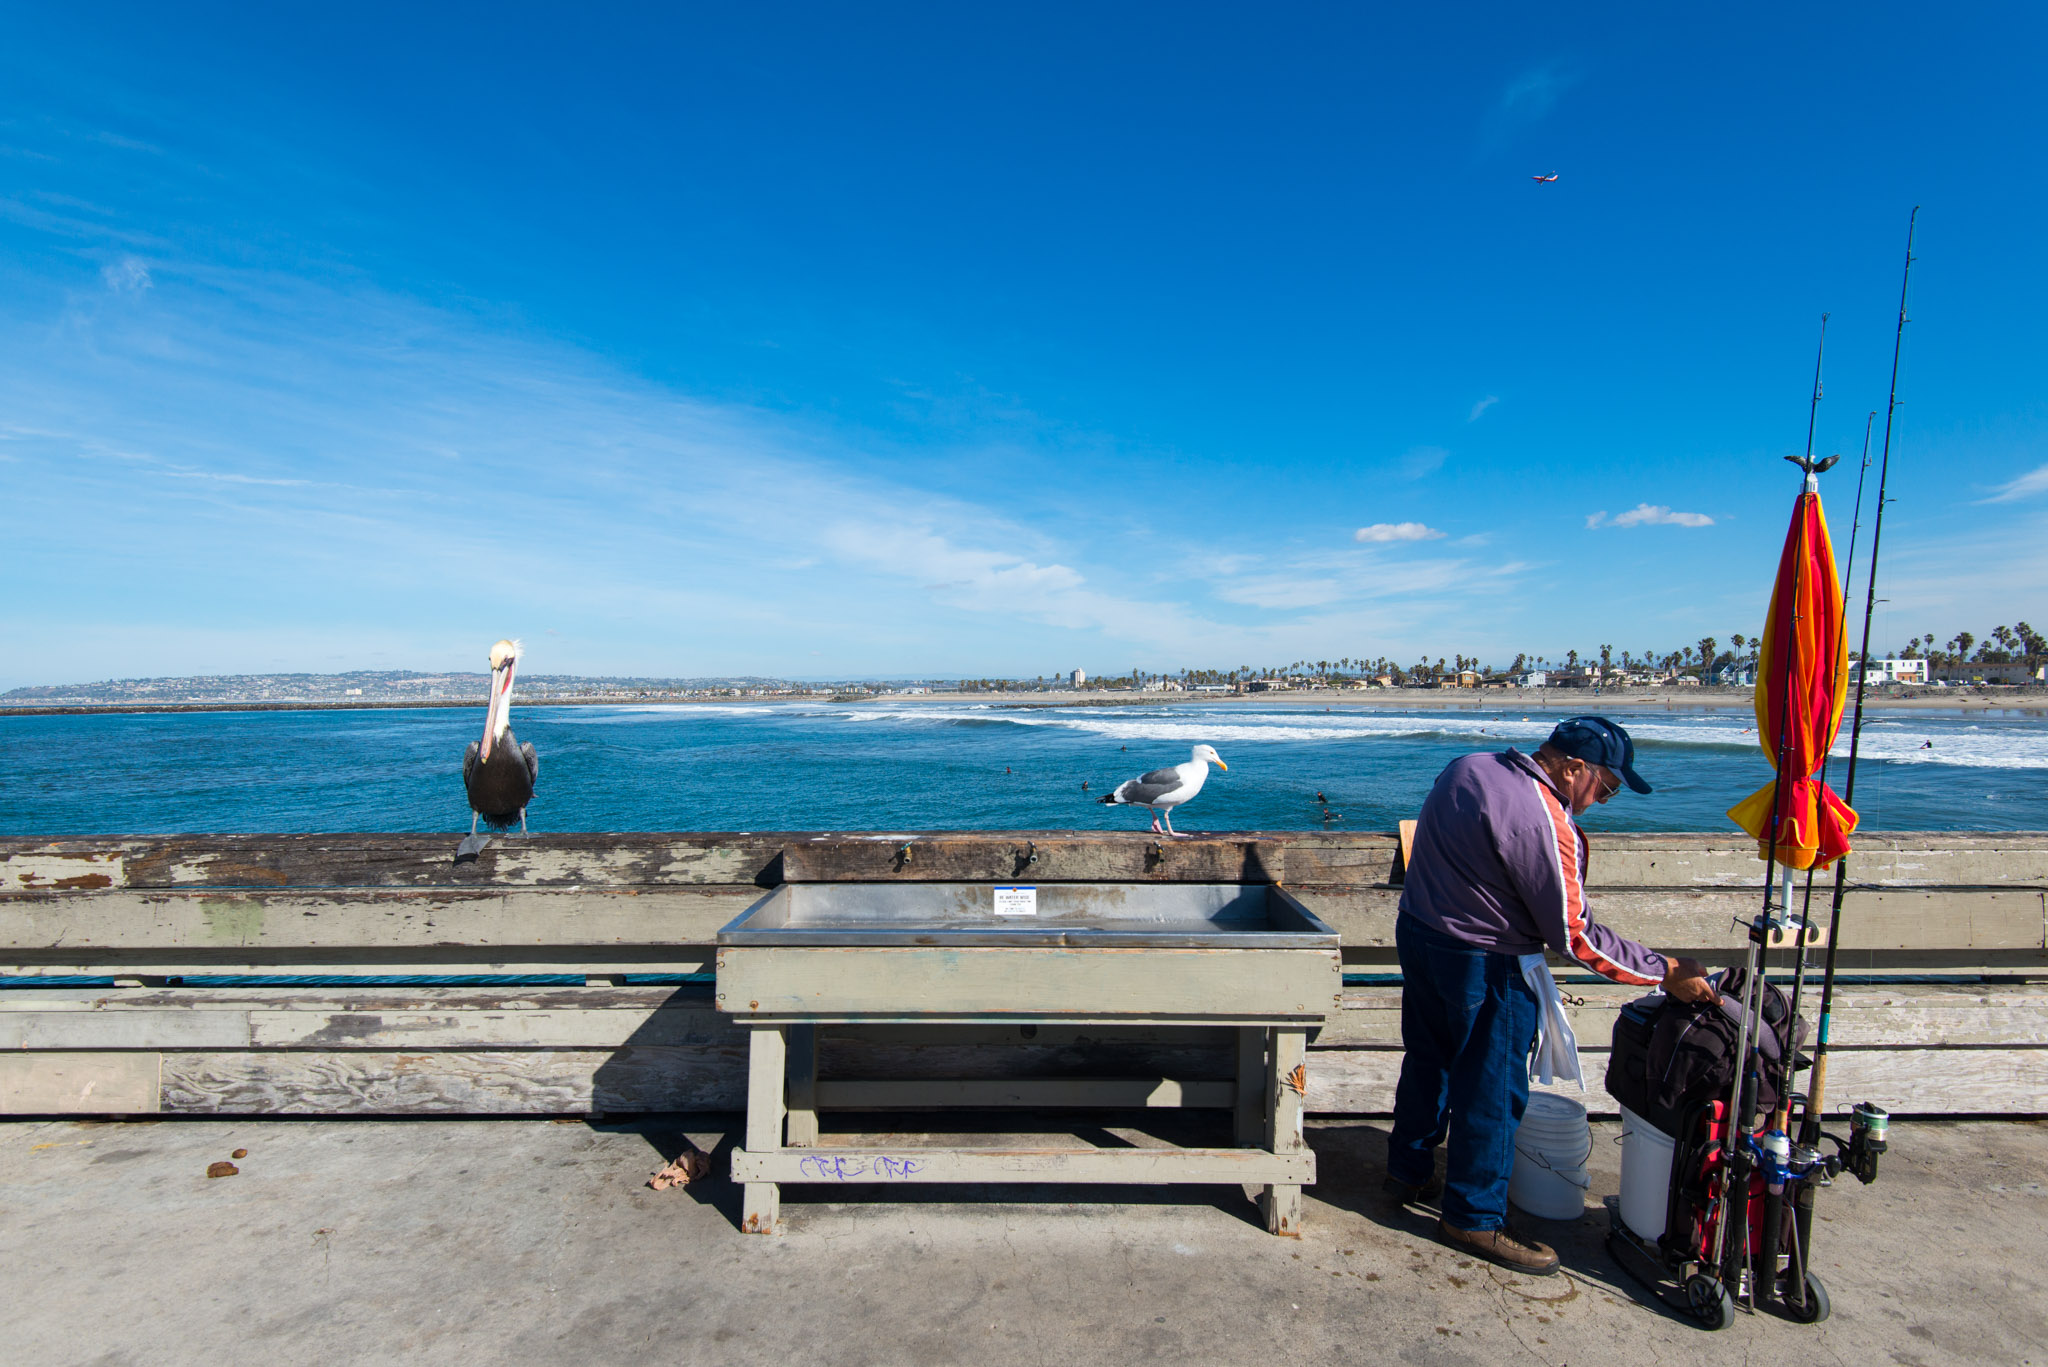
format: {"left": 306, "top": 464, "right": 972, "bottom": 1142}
{"left": 717, "top": 883, "right": 1343, "bottom": 1236}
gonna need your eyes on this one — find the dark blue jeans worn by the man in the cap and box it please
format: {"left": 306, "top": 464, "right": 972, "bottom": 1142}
{"left": 1386, "top": 916, "right": 1538, "bottom": 1230}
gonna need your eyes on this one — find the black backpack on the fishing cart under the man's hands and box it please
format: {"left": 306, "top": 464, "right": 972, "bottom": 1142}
{"left": 1608, "top": 967, "right": 1806, "bottom": 1135}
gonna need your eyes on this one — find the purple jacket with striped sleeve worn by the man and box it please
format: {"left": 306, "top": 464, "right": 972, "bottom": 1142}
{"left": 1401, "top": 750, "right": 1665, "bottom": 986}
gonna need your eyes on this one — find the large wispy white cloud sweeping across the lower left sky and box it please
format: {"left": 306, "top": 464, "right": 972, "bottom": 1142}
{"left": 12, "top": 251, "right": 1523, "bottom": 687}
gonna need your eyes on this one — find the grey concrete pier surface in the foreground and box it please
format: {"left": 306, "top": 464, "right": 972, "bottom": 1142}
{"left": 0, "top": 1115, "right": 2048, "bottom": 1367}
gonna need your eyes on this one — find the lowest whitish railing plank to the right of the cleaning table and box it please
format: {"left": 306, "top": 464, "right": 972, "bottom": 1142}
{"left": 1309, "top": 1049, "right": 2048, "bottom": 1115}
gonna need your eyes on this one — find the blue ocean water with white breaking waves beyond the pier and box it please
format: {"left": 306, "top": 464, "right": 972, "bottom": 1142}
{"left": 0, "top": 701, "right": 2048, "bottom": 836}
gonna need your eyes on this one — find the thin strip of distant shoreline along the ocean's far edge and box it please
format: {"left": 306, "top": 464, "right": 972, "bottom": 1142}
{"left": 0, "top": 689, "right": 2048, "bottom": 717}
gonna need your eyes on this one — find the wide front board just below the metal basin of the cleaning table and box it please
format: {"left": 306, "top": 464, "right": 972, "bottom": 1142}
{"left": 717, "top": 945, "right": 1343, "bottom": 1021}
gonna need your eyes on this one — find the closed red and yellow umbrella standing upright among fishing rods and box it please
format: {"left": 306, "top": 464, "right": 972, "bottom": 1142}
{"left": 1729, "top": 475, "right": 1858, "bottom": 869}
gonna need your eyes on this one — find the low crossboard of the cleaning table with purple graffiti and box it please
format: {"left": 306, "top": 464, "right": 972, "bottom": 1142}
{"left": 733, "top": 1146, "right": 1315, "bottom": 1187}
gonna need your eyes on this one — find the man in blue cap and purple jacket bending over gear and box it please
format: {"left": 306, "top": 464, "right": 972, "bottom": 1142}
{"left": 1384, "top": 717, "right": 1714, "bottom": 1275}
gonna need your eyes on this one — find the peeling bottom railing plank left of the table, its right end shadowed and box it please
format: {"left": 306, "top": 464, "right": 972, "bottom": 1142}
{"left": 155, "top": 1045, "right": 745, "bottom": 1115}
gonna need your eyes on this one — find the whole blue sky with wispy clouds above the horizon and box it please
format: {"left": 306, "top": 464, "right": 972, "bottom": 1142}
{"left": 0, "top": 6, "right": 2048, "bottom": 687}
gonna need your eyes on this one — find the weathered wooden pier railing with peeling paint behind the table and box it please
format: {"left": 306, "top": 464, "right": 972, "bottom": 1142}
{"left": 0, "top": 832, "right": 2048, "bottom": 1115}
